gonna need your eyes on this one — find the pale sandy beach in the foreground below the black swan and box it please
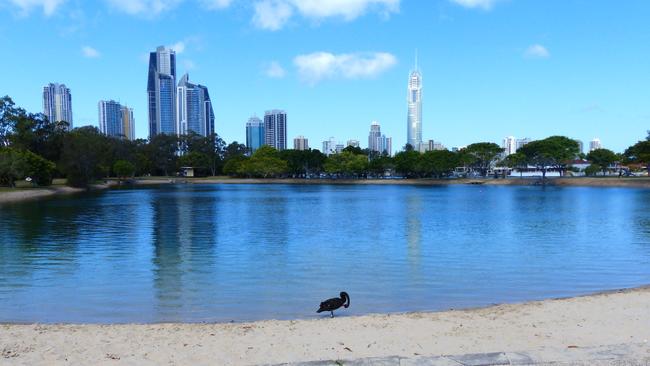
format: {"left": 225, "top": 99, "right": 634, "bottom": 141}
{"left": 0, "top": 288, "right": 650, "bottom": 365}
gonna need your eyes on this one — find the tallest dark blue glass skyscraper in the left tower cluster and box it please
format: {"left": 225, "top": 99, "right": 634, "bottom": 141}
{"left": 147, "top": 46, "right": 177, "bottom": 138}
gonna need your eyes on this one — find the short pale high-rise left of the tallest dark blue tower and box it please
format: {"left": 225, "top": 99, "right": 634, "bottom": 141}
{"left": 98, "top": 100, "right": 135, "bottom": 140}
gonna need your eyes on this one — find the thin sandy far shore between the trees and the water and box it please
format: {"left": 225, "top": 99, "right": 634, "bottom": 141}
{"left": 0, "top": 177, "right": 650, "bottom": 204}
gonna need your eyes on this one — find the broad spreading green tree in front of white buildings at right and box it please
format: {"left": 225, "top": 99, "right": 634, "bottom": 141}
{"left": 518, "top": 136, "right": 580, "bottom": 180}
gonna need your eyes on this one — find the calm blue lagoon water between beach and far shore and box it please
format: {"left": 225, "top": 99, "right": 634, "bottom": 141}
{"left": 0, "top": 185, "right": 650, "bottom": 323}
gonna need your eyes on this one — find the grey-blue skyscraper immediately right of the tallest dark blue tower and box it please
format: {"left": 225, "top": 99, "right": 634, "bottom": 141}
{"left": 176, "top": 74, "right": 214, "bottom": 136}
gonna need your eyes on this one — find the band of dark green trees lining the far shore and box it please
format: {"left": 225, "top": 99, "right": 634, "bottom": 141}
{"left": 0, "top": 96, "right": 650, "bottom": 187}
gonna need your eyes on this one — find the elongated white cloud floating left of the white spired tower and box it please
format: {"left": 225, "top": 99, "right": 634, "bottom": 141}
{"left": 293, "top": 52, "right": 397, "bottom": 85}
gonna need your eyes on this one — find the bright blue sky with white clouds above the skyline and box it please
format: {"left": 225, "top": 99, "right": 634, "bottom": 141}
{"left": 0, "top": 0, "right": 650, "bottom": 151}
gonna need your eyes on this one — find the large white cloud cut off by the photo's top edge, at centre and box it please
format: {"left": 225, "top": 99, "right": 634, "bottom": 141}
{"left": 253, "top": 0, "right": 400, "bottom": 30}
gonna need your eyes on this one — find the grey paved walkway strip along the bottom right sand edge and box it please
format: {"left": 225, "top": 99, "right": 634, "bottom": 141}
{"left": 268, "top": 343, "right": 650, "bottom": 366}
